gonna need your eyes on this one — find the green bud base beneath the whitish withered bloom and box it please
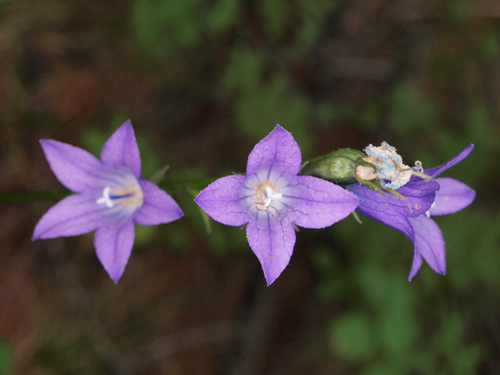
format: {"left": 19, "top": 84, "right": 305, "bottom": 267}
{"left": 300, "top": 148, "right": 365, "bottom": 185}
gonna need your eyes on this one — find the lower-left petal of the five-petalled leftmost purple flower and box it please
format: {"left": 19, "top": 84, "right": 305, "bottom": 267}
{"left": 32, "top": 194, "right": 110, "bottom": 240}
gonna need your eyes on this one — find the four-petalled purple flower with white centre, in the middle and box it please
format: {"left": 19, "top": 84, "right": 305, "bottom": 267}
{"left": 195, "top": 125, "right": 359, "bottom": 285}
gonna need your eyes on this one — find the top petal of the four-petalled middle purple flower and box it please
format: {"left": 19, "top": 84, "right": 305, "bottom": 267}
{"left": 247, "top": 125, "right": 302, "bottom": 176}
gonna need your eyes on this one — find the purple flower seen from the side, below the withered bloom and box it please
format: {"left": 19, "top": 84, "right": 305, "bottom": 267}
{"left": 348, "top": 144, "right": 475, "bottom": 281}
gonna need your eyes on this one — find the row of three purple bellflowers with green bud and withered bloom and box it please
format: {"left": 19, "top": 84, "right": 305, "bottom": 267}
{"left": 33, "top": 121, "right": 475, "bottom": 285}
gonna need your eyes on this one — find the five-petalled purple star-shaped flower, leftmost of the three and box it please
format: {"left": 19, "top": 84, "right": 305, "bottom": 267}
{"left": 32, "top": 121, "right": 183, "bottom": 283}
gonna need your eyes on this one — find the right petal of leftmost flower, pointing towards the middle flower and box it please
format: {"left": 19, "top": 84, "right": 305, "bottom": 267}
{"left": 133, "top": 180, "right": 183, "bottom": 225}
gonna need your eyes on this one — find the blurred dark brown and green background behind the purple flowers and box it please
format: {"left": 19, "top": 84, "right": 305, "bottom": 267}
{"left": 0, "top": 0, "right": 500, "bottom": 375}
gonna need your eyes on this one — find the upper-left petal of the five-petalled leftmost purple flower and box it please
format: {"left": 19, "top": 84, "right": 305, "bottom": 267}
{"left": 40, "top": 139, "right": 109, "bottom": 193}
